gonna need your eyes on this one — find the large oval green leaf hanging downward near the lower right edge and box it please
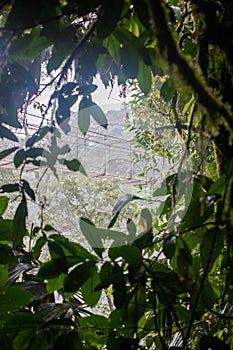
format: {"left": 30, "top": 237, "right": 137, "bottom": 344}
{"left": 200, "top": 228, "right": 224, "bottom": 271}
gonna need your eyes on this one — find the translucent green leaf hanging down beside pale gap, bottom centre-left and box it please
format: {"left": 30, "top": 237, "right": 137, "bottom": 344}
{"left": 81, "top": 265, "right": 102, "bottom": 307}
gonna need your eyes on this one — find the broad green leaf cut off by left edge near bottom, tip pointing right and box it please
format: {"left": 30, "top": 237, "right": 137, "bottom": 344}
{"left": 0, "top": 287, "right": 32, "bottom": 314}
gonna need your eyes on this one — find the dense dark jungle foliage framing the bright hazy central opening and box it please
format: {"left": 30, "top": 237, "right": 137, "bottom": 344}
{"left": 0, "top": 0, "right": 233, "bottom": 350}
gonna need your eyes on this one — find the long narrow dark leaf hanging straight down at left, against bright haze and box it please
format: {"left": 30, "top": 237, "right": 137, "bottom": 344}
{"left": 12, "top": 197, "right": 28, "bottom": 246}
